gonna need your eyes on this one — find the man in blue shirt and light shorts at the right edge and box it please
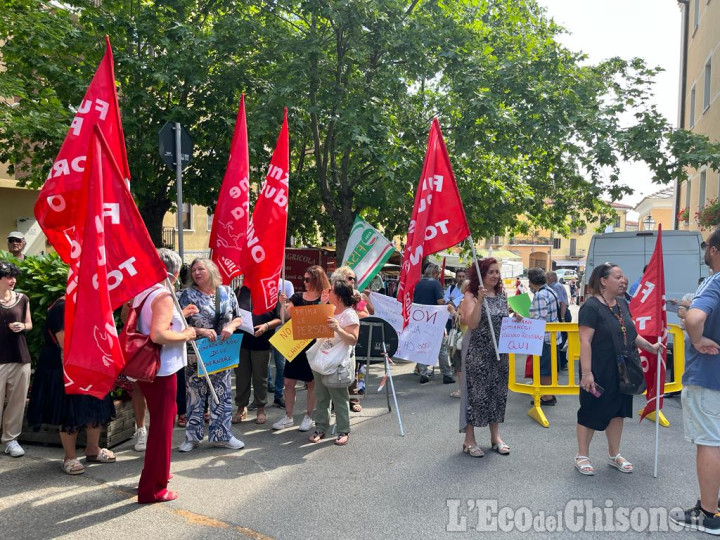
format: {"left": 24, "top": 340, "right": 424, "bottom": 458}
{"left": 670, "top": 228, "right": 720, "bottom": 535}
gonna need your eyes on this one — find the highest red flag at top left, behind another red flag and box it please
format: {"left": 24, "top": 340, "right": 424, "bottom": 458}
{"left": 35, "top": 36, "right": 130, "bottom": 264}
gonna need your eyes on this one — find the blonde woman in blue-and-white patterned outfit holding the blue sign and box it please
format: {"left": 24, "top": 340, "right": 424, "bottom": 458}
{"left": 178, "top": 259, "right": 245, "bottom": 452}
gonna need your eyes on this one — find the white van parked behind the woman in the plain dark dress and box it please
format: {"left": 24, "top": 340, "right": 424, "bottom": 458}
{"left": 583, "top": 231, "right": 710, "bottom": 324}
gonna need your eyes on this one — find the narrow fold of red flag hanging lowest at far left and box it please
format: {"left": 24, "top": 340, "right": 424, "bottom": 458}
{"left": 63, "top": 125, "right": 125, "bottom": 399}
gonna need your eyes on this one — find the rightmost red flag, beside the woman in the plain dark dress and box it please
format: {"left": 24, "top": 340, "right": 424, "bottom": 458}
{"left": 630, "top": 226, "right": 667, "bottom": 421}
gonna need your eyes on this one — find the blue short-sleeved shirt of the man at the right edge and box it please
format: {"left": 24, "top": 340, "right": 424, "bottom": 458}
{"left": 683, "top": 273, "right": 720, "bottom": 390}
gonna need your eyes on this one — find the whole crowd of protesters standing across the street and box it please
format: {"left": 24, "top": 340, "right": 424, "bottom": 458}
{"left": 0, "top": 229, "right": 720, "bottom": 532}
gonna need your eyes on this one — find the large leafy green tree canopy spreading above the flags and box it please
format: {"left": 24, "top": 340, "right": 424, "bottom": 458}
{"left": 0, "top": 0, "right": 720, "bottom": 253}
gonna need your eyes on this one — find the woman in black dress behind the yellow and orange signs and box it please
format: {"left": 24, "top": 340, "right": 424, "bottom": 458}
{"left": 273, "top": 265, "right": 330, "bottom": 431}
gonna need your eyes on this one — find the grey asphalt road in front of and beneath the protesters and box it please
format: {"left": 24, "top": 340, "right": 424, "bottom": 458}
{"left": 0, "top": 352, "right": 697, "bottom": 540}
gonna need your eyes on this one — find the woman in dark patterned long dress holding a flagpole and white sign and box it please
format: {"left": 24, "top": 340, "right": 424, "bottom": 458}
{"left": 460, "top": 257, "right": 510, "bottom": 457}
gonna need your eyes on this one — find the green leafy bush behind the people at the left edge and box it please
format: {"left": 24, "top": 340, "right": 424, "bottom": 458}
{"left": 0, "top": 251, "right": 68, "bottom": 361}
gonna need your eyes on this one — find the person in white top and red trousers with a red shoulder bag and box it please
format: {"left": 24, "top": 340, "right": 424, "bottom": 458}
{"left": 132, "top": 248, "right": 197, "bottom": 504}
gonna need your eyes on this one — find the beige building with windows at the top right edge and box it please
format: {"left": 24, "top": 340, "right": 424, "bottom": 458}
{"left": 673, "top": 0, "right": 720, "bottom": 235}
